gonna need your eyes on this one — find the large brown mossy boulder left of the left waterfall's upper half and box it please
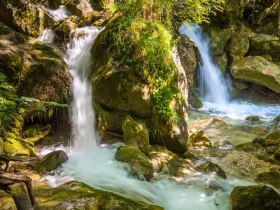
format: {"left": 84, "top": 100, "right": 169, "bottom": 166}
{"left": 0, "top": 22, "right": 70, "bottom": 102}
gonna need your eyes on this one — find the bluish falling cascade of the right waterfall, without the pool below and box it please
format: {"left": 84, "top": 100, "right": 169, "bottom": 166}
{"left": 179, "top": 24, "right": 229, "bottom": 104}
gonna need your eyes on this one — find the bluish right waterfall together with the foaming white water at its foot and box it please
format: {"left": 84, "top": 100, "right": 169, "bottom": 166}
{"left": 179, "top": 24, "right": 280, "bottom": 121}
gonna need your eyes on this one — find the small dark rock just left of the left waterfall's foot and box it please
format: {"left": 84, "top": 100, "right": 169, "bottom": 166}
{"left": 33, "top": 150, "right": 68, "bottom": 174}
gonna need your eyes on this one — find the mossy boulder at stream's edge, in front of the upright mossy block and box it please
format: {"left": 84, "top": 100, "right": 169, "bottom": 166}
{"left": 115, "top": 146, "right": 153, "bottom": 180}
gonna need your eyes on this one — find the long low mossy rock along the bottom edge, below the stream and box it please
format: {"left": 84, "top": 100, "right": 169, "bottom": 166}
{"left": 34, "top": 181, "right": 162, "bottom": 210}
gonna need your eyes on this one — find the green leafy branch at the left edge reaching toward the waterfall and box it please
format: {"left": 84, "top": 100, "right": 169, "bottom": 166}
{"left": 0, "top": 72, "right": 68, "bottom": 131}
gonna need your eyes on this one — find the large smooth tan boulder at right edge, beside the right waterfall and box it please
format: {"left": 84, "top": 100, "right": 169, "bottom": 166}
{"left": 231, "top": 56, "right": 280, "bottom": 93}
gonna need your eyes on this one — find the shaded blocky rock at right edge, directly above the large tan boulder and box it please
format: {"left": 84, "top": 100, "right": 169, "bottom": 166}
{"left": 250, "top": 34, "right": 280, "bottom": 60}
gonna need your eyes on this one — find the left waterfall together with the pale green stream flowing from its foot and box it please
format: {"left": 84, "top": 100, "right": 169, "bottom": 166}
{"left": 43, "top": 27, "right": 233, "bottom": 210}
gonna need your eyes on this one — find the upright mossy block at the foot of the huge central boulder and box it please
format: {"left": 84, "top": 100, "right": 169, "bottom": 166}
{"left": 122, "top": 116, "right": 149, "bottom": 153}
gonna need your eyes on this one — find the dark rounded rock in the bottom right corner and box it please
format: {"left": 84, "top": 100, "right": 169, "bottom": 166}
{"left": 230, "top": 185, "right": 280, "bottom": 210}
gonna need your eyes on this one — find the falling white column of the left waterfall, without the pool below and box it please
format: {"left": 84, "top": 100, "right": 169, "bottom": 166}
{"left": 67, "top": 27, "right": 101, "bottom": 152}
